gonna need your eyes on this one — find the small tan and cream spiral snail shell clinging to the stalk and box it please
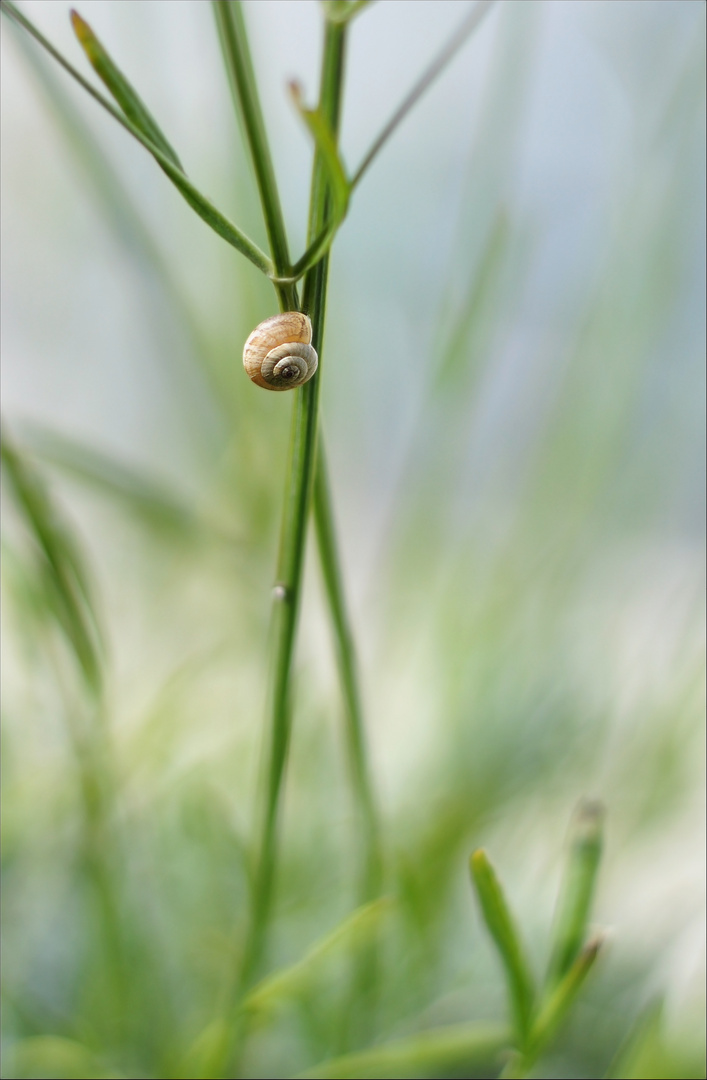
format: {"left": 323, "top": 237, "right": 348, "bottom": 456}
{"left": 243, "top": 311, "right": 318, "bottom": 390}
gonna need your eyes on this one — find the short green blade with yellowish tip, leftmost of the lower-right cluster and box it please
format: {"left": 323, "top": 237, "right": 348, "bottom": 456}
{"left": 471, "top": 850, "right": 534, "bottom": 1045}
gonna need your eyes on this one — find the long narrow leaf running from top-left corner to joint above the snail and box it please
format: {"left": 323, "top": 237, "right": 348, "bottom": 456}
{"left": 0, "top": 0, "right": 273, "bottom": 276}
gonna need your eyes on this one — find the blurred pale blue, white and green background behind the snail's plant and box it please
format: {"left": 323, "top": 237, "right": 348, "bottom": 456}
{"left": 2, "top": 0, "right": 706, "bottom": 1077}
